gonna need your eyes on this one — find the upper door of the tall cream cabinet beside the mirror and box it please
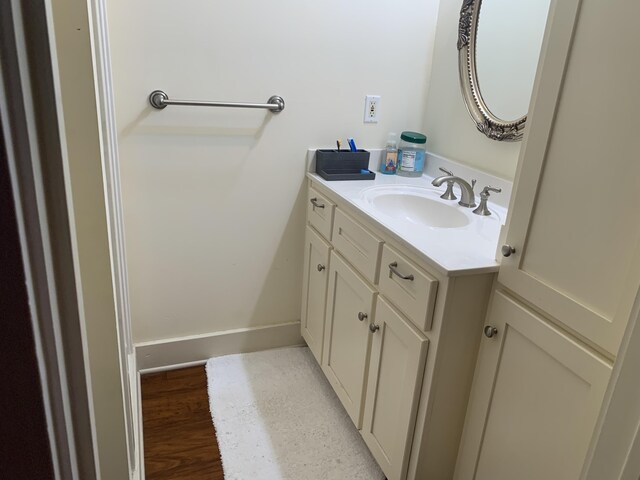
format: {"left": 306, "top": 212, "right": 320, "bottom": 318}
{"left": 499, "top": 0, "right": 640, "bottom": 355}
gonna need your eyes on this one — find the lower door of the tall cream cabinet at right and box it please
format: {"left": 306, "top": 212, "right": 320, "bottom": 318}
{"left": 455, "top": 291, "right": 611, "bottom": 480}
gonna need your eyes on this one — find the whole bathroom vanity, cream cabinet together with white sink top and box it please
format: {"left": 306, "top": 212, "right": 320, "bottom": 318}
{"left": 302, "top": 162, "right": 506, "bottom": 480}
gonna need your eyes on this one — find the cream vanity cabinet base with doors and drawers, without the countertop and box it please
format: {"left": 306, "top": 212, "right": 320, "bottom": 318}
{"left": 301, "top": 177, "right": 495, "bottom": 480}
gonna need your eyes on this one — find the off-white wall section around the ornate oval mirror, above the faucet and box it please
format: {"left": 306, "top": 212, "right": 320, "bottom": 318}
{"left": 424, "top": 0, "right": 520, "bottom": 180}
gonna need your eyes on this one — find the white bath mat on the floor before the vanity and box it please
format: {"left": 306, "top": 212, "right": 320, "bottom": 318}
{"left": 207, "top": 347, "right": 384, "bottom": 480}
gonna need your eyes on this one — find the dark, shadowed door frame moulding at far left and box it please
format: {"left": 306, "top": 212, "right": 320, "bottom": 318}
{"left": 0, "top": 0, "right": 97, "bottom": 480}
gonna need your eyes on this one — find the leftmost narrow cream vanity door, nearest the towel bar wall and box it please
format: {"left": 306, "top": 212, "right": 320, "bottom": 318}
{"left": 300, "top": 227, "right": 331, "bottom": 364}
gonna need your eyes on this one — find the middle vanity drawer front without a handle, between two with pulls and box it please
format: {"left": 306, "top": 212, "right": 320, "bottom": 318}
{"left": 331, "top": 210, "right": 384, "bottom": 284}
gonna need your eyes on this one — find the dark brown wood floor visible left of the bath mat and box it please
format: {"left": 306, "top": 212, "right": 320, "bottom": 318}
{"left": 141, "top": 366, "right": 224, "bottom": 480}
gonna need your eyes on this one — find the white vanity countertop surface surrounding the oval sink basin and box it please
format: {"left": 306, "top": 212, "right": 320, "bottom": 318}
{"left": 307, "top": 172, "right": 507, "bottom": 276}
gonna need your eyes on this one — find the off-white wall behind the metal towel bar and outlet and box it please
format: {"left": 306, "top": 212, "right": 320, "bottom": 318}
{"left": 108, "top": 0, "right": 440, "bottom": 342}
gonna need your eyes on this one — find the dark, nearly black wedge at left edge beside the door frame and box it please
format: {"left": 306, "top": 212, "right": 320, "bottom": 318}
{"left": 0, "top": 119, "right": 54, "bottom": 480}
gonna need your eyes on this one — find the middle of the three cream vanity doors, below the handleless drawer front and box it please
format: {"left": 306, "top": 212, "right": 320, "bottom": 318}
{"left": 322, "top": 252, "right": 376, "bottom": 429}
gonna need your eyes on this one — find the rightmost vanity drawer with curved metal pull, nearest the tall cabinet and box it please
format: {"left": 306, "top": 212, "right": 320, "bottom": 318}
{"left": 380, "top": 245, "right": 438, "bottom": 330}
